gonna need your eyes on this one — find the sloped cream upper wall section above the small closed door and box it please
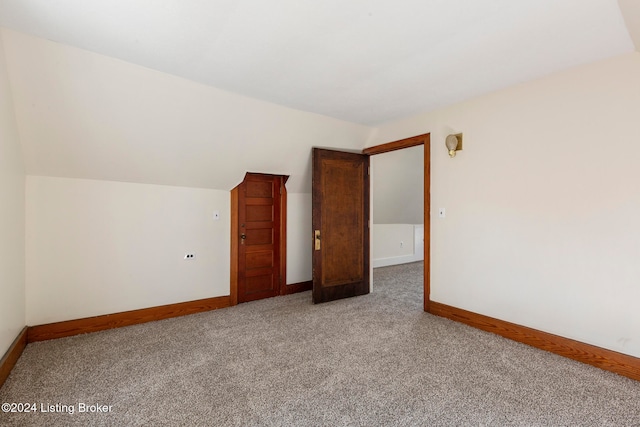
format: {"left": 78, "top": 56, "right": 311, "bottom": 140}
{"left": 0, "top": 29, "right": 371, "bottom": 193}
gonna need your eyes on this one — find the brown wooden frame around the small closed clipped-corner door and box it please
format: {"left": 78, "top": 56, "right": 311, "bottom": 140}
{"left": 229, "top": 172, "right": 289, "bottom": 306}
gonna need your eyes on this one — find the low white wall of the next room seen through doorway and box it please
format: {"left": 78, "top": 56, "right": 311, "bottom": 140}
{"left": 371, "top": 224, "right": 424, "bottom": 268}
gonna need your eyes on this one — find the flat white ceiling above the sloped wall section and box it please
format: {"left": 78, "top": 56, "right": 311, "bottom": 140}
{"left": 0, "top": 0, "right": 640, "bottom": 125}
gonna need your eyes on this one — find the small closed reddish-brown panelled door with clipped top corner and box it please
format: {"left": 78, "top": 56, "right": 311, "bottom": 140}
{"left": 237, "top": 173, "right": 284, "bottom": 302}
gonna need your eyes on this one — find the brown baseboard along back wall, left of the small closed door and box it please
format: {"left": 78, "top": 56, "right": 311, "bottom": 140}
{"left": 27, "top": 296, "right": 232, "bottom": 343}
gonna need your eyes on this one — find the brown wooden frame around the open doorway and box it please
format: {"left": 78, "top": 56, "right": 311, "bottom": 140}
{"left": 362, "top": 133, "right": 431, "bottom": 313}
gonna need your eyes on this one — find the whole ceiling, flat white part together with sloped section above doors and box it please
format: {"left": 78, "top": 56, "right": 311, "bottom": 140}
{"left": 0, "top": 0, "right": 637, "bottom": 192}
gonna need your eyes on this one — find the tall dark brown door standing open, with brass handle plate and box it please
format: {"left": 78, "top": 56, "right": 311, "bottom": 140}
{"left": 312, "top": 148, "right": 369, "bottom": 303}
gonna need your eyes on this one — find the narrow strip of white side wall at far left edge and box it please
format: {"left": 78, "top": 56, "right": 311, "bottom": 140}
{"left": 0, "top": 30, "right": 26, "bottom": 358}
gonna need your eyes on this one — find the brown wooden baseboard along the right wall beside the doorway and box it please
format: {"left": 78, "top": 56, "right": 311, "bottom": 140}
{"left": 429, "top": 301, "right": 640, "bottom": 381}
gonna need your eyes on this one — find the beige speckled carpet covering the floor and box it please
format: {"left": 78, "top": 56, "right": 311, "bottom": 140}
{"left": 0, "top": 263, "right": 640, "bottom": 426}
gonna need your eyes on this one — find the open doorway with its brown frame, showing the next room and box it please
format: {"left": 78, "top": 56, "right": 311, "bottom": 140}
{"left": 363, "top": 134, "right": 430, "bottom": 311}
